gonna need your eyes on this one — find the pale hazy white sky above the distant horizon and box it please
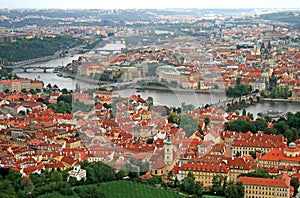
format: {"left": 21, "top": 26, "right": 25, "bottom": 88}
{"left": 0, "top": 0, "right": 300, "bottom": 9}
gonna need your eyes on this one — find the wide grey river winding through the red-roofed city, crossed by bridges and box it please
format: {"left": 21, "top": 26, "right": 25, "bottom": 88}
{"left": 14, "top": 54, "right": 300, "bottom": 117}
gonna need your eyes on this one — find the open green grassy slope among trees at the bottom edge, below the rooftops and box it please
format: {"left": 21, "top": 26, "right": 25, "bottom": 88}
{"left": 79, "top": 181, "right": 184, "bottom": 198}
